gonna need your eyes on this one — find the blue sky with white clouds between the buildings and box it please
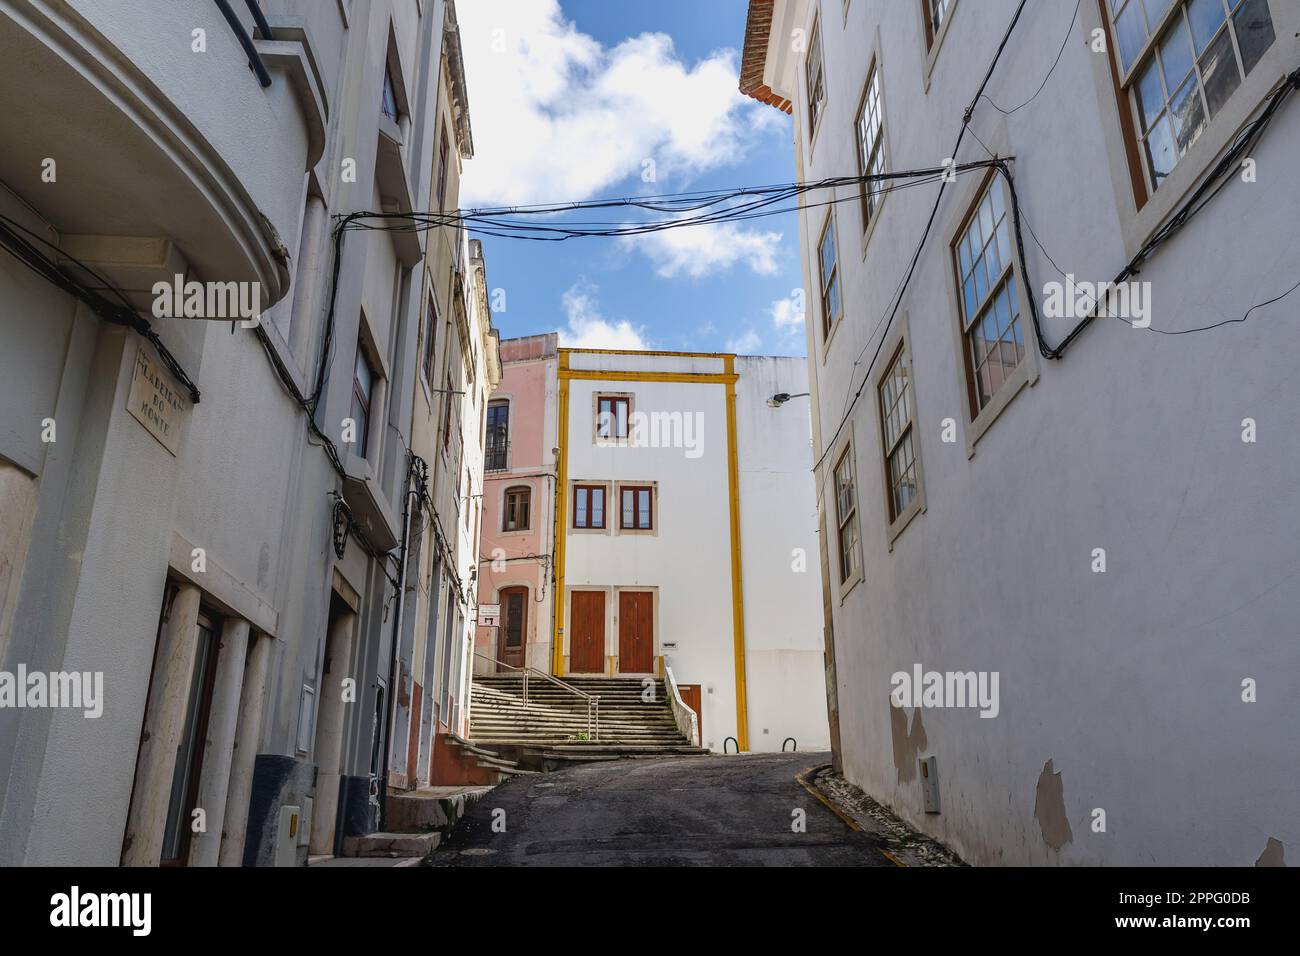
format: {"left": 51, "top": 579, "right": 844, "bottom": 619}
{"left": 458, "top": 0, "right": 803, "bottom": 355}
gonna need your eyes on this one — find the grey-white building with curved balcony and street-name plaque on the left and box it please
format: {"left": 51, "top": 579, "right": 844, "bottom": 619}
{"left": 0, "top": 0, "right": 490, "bottom": 865}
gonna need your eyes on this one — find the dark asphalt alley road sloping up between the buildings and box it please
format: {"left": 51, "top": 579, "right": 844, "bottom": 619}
{"left": 430, "top": 753, "right": 893, "bottom": 866}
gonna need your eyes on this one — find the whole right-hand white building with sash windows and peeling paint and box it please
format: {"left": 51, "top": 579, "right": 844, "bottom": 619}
{"left": 741, "top": 0, "right": 1300, "bottom": 865}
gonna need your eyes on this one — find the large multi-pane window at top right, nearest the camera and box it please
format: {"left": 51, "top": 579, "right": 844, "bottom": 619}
{"left": 1102, "top": 0, "right": 1277, "bottom": 190}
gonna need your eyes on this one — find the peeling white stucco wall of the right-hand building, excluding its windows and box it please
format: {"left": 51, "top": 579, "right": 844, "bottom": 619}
{"left": 774, "top": 0, "right": 1300, "bottom": 865}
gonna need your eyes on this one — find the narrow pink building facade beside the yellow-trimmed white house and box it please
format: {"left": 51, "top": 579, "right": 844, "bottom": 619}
{"left": 475, "top": 333, "right": 558, "bottom": 674}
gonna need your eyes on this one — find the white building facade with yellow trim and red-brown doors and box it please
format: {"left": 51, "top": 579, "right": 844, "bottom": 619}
{"left": 551, "top": 349, "right": 828, "bottom": 750}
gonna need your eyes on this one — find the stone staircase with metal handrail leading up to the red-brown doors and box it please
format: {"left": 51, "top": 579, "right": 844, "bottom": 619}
{"left": 469, "top": 674, "right": 709, "bottom": 771}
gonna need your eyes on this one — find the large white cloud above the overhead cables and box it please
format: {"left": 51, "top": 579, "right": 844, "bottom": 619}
{"left": 458, "top": 0, "right": 783, "bottom": 206}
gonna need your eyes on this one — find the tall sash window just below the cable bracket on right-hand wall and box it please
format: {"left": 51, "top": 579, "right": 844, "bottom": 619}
{"left": 953, "top": 178, "right": 1024, "bottom": 420}
